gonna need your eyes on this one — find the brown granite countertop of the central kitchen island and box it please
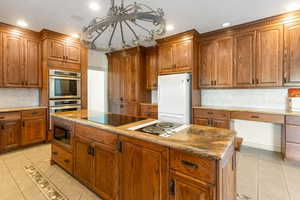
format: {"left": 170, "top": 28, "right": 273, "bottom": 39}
{"left": 52, "top": 110, "right": 235, "bottom": 160}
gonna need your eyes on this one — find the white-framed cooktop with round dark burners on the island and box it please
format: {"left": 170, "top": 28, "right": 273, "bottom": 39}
{"left": 129, "top": 121, "right": 187, "bottom": 137}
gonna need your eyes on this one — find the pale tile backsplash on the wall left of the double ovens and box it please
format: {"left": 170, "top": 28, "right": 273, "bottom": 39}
{"left": 0, "top": 88, "right": 39, "bottom": 108}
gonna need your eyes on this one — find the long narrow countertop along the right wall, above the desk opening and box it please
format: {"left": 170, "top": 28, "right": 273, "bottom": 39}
{"left": 193, "top": 106, "right": 300, "bottom": 116}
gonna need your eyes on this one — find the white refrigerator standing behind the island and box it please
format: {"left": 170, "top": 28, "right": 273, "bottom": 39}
{"left": 157, "top": 73, "right": 192, "bottom": 124}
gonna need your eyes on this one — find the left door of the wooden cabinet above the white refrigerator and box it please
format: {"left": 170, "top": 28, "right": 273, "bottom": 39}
{"left": 158, "top": 44, "right": 174, "bottom": 74}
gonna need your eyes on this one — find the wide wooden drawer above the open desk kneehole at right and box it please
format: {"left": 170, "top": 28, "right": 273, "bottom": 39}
{"left": 231, "top": 111, "right": 284, "bottom": 124}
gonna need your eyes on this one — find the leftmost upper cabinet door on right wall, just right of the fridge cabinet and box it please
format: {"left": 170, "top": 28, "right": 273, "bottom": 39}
{"left": 199, "top": 42, "right": 216, "bottom": 88}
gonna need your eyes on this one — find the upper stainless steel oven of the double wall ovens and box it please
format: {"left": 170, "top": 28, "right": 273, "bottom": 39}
{"left": 49, "top": 70, "right": 81, "bottom": 99}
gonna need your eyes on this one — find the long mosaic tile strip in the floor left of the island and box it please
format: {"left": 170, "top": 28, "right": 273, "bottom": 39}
{"left": 24, "top": 165, "right": 69, "bottom": 200}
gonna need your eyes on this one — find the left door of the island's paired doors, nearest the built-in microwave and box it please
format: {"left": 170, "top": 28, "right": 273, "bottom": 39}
{"left": 74, "top": 137, "right": 93, "bottom": 186}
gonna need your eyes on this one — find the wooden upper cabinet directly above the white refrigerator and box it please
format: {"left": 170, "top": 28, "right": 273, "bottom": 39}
{"left": 157, "top": 30, "right": 198, "bottom": 74}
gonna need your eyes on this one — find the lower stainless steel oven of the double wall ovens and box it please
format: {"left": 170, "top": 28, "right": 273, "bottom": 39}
{"left": 49, "top": 99, "right": 81, "bottom": 129}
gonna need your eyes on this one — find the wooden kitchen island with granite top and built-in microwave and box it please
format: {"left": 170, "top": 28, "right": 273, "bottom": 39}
{"left": 51, "top": 110, "right": 236, "bottom": 200}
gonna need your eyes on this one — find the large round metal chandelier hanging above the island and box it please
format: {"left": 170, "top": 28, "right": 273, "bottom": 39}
{"left": 82, "top": 0, "right": 166, "bottom": 51}
